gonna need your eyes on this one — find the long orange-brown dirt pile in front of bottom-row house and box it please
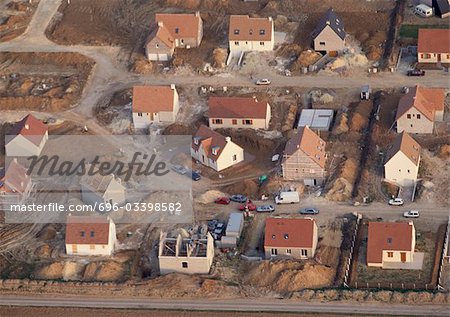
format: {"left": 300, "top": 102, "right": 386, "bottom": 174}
{"left": 243, "top": 260, "right": 335, "bottom": 293}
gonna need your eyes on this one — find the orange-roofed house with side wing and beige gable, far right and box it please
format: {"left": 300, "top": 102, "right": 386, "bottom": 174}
{"left": 395, "top": 85, "right": 445, "bottom": 133}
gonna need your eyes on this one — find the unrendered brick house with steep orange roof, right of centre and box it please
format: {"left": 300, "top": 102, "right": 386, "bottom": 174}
{"left": 281, "top": 126, "right": 327, "bottom": 186}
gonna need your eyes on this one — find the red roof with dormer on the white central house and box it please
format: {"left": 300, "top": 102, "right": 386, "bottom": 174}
{"left": 192, "top": 125, "right": 234, "bottom": 161}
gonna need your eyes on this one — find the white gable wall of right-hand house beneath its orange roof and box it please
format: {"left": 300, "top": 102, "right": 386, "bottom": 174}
{"left": 384, "top": 152, "right": 420, "bottom": 186}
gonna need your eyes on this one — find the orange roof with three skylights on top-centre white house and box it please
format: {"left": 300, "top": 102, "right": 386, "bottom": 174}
{"left": 228, "top": 15, "right": 273, "bottom": 41}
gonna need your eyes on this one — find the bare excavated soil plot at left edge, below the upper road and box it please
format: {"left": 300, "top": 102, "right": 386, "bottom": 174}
{"left": 0, "top": 53, "right": 94, "bottom": 112}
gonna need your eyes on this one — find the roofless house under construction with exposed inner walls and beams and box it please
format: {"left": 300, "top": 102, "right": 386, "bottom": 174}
{"left": 158, "top": 227, "right": 214, "bottom": 274}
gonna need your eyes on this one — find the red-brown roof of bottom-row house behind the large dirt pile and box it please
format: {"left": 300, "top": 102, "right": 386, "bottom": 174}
{"left": 264, "top": 218, "right": 315, "bottom": 248}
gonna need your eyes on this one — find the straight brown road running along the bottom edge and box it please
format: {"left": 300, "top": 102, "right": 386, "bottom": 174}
{"left": 0, "top": 296, "right": 448, "bottom": 316}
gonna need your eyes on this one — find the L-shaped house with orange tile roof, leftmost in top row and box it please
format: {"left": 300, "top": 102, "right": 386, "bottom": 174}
{"left": 145, "top": 12, "right": 203, "bottom": 61}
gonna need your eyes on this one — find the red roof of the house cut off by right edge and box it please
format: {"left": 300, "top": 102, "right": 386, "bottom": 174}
{"left": 417, "top": 29, "right": 450, "bottom": 53}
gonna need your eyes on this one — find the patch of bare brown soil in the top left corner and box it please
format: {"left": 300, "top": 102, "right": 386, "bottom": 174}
{"left": 0, "top": 0, "right": 39, "bottom": 42}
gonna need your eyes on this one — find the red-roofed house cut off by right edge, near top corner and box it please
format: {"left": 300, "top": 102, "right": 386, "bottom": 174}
{"left": 417, "top": 29, "right": 450, "bottom": 64}
